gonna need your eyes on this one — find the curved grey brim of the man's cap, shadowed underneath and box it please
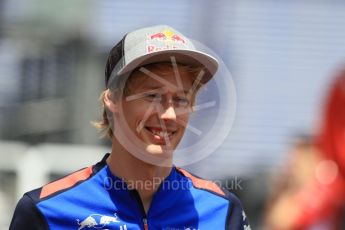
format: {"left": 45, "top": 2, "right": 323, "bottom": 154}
{"left": 118, "top": 49, "right": 218, "bottom": 84}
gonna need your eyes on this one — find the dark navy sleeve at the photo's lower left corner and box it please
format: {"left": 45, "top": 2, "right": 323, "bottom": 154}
{"left": 9, "top": 194, "right": 49, "bottom": 230}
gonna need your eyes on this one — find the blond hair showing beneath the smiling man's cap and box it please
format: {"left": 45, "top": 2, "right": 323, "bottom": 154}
{"left": 92, "top": 62, "right": 205, "bottom": 139}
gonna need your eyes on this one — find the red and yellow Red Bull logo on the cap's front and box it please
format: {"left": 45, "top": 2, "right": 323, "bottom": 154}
{"left": 147, "top": 30, "right": 186, "bottom": 53}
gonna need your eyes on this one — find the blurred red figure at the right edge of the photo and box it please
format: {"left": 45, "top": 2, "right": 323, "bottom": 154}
{"left": 294, "top": 69, "right": 345, "bottom": 230}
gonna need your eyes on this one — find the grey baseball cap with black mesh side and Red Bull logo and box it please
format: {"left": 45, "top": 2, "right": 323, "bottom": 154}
{"left": 106, "top": 25, "right": 218, "bottom": 84}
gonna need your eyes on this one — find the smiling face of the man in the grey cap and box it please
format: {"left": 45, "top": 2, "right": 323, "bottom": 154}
{"left": 115, "top": 64, "right": 195, "bottom": 157}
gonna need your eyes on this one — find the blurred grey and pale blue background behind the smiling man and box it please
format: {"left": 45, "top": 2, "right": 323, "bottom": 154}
{"left": 0, "top": 0, "right": 345, "bottom": 229}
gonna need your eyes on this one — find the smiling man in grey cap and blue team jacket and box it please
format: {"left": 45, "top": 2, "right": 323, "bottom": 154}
{"left": 10, "top": 26, "right": 250, "bottom": 230}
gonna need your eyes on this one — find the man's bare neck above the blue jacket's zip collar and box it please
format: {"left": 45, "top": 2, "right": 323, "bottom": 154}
{"left": 107, "top": 139, "right": 172, "bottom": 212}
